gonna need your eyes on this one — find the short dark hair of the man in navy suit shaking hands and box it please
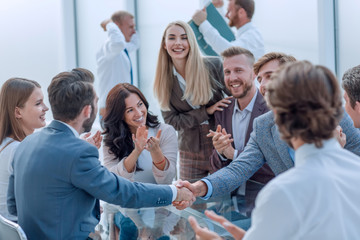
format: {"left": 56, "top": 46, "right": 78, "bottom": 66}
{"left": 48, "top": 68, "right": 95, "bottom": 122}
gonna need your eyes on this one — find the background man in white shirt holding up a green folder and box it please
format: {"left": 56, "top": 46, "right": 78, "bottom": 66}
{"left": 192, "top": 0, "right": 265, "bottom": 60}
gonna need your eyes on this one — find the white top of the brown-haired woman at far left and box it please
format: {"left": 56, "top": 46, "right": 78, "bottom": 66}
{"left": 0, "top": 137, "right": 20, "bottom": 221}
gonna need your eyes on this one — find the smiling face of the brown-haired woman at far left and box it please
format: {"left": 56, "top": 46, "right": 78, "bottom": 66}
{"left": 15, "top": 87, "right": 49, "bottom": 135}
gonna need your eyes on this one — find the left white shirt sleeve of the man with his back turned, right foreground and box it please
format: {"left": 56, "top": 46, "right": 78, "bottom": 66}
{"left": 243, "top": 182, "right": 302, "bottom": 240}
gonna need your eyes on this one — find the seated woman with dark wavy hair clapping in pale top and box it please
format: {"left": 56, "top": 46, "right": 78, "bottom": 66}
{"left": 103, "top": 83, "right": 178, "bottom": 184}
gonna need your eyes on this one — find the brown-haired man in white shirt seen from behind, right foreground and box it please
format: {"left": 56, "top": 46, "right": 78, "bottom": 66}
{"left": 189, "top": 61, "right": 360, "bottom": 240}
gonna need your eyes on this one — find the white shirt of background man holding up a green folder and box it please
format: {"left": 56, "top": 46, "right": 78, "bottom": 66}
{"left": 199, "top": 20, "right": 265, "bottom": 61}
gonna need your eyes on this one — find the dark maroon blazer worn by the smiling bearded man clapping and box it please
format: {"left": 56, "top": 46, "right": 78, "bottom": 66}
{"left": 210, "top": 91, "right": 275, "bottom": 183}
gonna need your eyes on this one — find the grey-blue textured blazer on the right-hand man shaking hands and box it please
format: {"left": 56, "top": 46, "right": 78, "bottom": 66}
{"left": 206, "top": 111, "right": 360, "bottom": 197}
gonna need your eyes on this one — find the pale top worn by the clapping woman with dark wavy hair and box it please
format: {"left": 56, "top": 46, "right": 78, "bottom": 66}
{"left": 103, "top": 123, "right": 178, "bottom": 184}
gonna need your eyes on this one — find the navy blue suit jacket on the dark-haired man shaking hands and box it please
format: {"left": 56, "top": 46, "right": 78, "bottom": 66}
{"left": 8, "top": 121, "right": 172, "bottom": 240}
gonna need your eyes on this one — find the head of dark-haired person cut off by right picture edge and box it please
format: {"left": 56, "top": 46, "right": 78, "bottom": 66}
{"left": 342, "top": 65, "right": 360, "bottom": 128}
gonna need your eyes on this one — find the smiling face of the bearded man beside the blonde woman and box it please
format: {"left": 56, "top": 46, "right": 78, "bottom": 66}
{"left": 223, "top": 54, "right": 255, "bottom": 98}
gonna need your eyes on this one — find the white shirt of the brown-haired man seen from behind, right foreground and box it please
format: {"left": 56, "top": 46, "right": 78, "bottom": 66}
{"left": 244, "top": 139, "right": 360, "bottom": 240}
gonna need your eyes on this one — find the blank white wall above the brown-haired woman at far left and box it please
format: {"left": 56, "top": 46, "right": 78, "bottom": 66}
{"left": 0, "top": 0, "right": 75, "bottom": 119}
